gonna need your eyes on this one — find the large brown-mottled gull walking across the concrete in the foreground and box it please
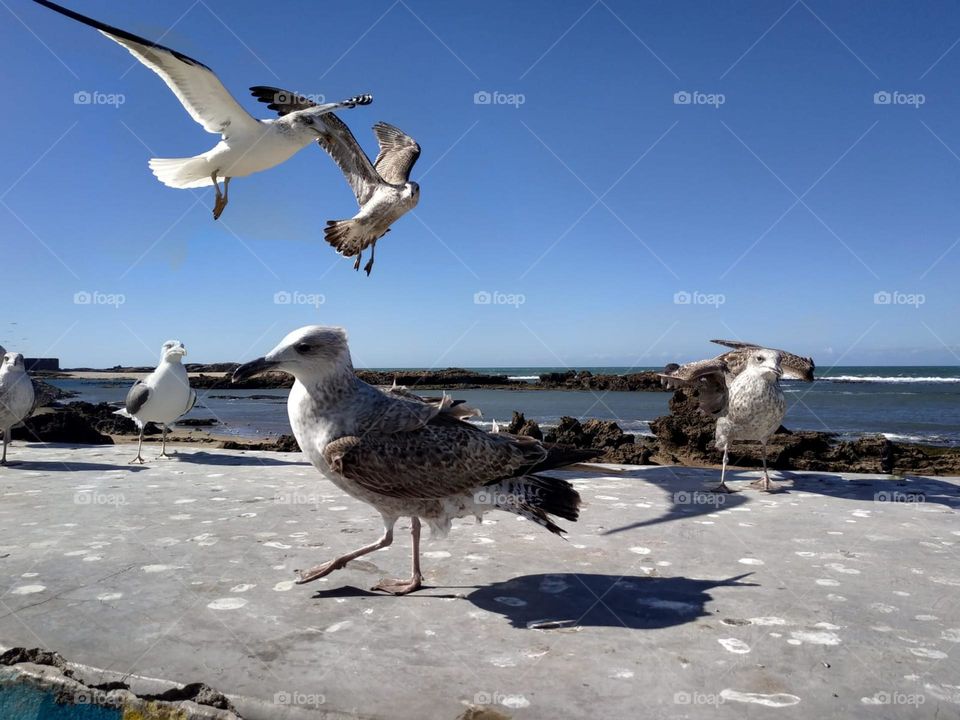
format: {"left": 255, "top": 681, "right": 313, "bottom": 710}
{"left": 233, "top": 326, "right": 594, "bottom": 595}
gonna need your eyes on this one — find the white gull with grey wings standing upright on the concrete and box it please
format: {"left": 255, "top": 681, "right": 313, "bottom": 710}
{"left": 116, "top": 340, "right": 197, "bottom": 464}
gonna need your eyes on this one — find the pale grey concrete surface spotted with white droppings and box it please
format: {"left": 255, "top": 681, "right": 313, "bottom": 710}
{"left": 0, "top": 443, "right": 960, "bottom": 720}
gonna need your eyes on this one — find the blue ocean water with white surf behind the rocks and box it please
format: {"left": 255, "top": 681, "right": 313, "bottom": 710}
{"left": 53, "top": 366, "right": 960, "bottom": 446}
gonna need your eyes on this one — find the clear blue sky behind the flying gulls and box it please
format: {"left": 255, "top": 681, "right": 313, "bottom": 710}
{"left": 0, "top": 0, "right": 960, "bottom": 367}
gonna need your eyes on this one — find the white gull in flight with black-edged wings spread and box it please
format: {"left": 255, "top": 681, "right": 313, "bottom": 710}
{"left": 34, "top": 0, "right": 373, "bottom": 219}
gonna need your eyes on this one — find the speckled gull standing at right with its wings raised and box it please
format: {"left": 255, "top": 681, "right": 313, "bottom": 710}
{"left": 662, "top": 340, "right": 815, "bottom": 492}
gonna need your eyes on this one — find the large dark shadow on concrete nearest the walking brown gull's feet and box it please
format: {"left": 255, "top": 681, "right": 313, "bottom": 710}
{"left": 467, "top": 573, "right": 756, "bottom": 630}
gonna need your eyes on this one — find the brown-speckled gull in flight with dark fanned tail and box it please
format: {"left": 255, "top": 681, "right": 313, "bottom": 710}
{"left": 250, "top": 87, "right": 420, "bottom": 275}
